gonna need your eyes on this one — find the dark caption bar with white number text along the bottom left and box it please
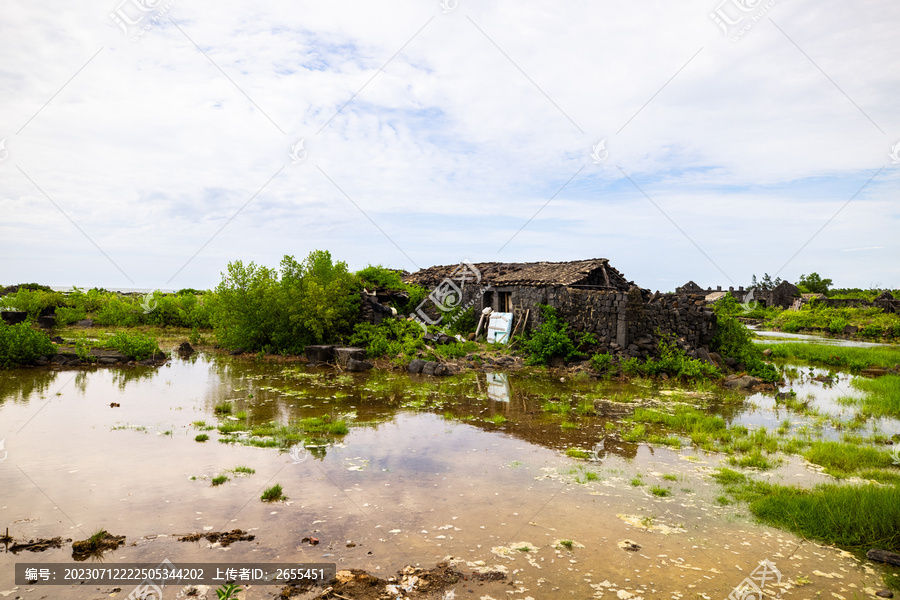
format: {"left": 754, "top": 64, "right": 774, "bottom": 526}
{"left": 16, "top": 560, "right": 337, "bottom": 587}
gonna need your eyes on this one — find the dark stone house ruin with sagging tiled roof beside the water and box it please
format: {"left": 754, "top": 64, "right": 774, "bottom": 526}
{"left": 403, "top": 258, "right": 716, "bottom": 356}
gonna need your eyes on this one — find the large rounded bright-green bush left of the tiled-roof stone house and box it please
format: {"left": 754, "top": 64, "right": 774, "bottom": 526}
{"left": 210, "top": 251, "right": 359, "bottom": 353}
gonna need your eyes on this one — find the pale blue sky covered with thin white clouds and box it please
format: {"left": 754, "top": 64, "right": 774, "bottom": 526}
{"left": 0, "top": 0, "right": 900, "bottom": 291}
